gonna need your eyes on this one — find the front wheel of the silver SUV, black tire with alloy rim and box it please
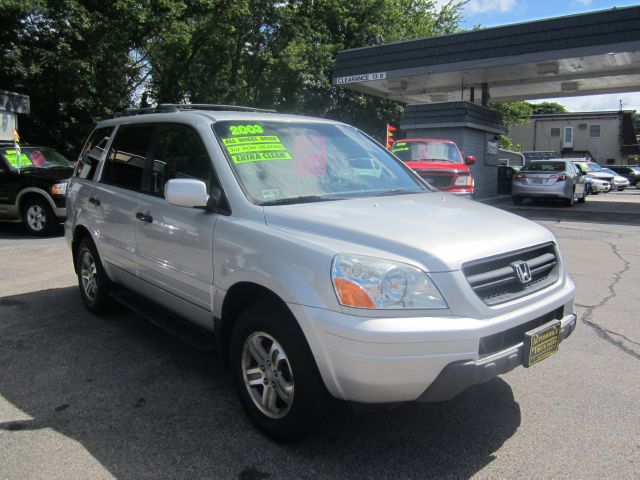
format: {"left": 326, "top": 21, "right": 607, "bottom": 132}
{"left": 231, "top": 302, "right": 329, "bottom": 441}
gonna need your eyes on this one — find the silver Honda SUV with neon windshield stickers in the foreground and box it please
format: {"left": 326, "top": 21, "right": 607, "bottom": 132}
{"left": 65, "top": 105, "right": 576, "bottom": 439}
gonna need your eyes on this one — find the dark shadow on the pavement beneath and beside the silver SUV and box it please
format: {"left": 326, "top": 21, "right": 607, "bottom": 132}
{"left": 0, "top": 287, "right": 520, "bottom": 480}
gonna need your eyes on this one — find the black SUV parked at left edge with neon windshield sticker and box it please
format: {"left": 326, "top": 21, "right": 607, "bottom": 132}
{"left": 0, "top": 143, "right": 73, "bottom": 235}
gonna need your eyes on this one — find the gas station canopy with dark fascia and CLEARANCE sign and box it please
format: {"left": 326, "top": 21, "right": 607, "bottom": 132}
{"left": 333, "top": 7, "right": 640, "bottom": 105}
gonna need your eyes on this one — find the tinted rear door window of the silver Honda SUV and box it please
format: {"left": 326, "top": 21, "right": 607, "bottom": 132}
{"left": 102, "top": 125, "right": 154, "bottom": 190}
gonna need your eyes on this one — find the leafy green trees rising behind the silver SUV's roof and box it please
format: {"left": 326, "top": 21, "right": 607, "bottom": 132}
{"left": 0, "top": 0, "right": 464, "bottom": 156}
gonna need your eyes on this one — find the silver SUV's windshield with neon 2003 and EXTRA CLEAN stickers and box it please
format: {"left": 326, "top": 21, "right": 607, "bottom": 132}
{"left": 213, "top": 121, "right": 430, "bottom": 205}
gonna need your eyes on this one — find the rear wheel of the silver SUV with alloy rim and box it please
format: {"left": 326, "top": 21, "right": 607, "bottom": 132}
{"left": 76, "top": 238, "right": 113, "bottom": 315}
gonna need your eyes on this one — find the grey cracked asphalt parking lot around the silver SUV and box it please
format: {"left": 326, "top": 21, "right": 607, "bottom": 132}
{"left": 0, "top": 190, "right": 640, "bottom": 480}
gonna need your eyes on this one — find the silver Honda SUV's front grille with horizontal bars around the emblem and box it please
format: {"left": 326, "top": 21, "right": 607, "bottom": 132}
{"left": 462, "top": 243, "right": 559, "bottom": 305}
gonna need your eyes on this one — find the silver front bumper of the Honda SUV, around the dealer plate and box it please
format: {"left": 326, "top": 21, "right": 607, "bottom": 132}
{"left": 289, "top": 278, "right": 575, "bottom": 403}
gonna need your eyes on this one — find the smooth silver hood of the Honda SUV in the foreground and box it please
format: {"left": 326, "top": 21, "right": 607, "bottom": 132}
{"left": 264, "top": 192, "right": 554, "bottom": 272}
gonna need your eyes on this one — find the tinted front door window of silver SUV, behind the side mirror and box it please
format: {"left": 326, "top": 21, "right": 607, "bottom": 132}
{"left": 151, "top": 124, "right": 212, "bottom": 196}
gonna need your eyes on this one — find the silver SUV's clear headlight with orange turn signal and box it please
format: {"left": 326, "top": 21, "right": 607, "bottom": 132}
{"left": 331, "top": 253, "right": 447, "bottom": 309}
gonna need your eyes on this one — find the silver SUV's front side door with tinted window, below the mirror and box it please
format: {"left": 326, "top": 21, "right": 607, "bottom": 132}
{"left": 134, "top": 124, "right": 219, "bottom": 322}
